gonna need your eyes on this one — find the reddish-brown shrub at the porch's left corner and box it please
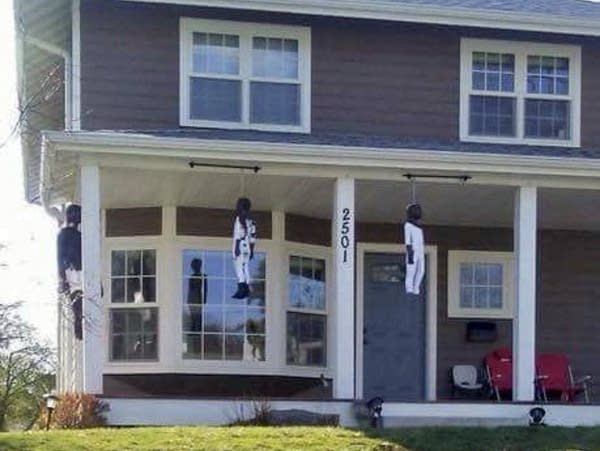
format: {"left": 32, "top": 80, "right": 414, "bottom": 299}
{"left": 38, "top": 393, "right": 110, "bottom": 429}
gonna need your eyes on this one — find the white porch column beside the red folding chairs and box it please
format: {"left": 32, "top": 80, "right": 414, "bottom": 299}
{"left": 513, "top": 186, "right": 537, "bottom": 401}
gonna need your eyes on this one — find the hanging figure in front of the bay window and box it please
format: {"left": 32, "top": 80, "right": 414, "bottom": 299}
{"left": 232, "top": 197, "right": 256, "bottom": 299}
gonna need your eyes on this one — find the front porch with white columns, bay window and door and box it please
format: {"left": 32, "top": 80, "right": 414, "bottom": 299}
{"left": 43, "top": 132, "right": 600, "bottom": 425}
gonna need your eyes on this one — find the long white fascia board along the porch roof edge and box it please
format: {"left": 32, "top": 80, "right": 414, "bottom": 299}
{"left": 44, "top": 131, "right": 600, "bottom": 178}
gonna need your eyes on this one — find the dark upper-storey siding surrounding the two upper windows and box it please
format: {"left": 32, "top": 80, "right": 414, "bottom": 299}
{"left": 81, "top": 0, "right": 600, "bottom": 146}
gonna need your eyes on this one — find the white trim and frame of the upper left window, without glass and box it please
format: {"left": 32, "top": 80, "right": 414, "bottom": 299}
{"left": 179, "top": 17, "right": 311, "bottom": 133}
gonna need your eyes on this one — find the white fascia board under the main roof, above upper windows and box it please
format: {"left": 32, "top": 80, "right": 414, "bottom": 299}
{"left": 121, "top": 0, "right": 600, "bottom": 36}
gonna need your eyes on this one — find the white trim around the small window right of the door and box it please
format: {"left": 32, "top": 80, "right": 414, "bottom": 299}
{"left": 448, "top": 250, "right": 514, "bottom": 319}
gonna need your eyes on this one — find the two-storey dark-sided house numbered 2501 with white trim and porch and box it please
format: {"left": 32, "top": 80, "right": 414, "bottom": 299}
{"left": 15, "top": 0, "right": 600, "bottom": 425}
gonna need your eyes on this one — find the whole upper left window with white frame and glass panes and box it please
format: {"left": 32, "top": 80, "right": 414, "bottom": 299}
{"left": 180, "top": 18, "right": 310, "bottom": 132}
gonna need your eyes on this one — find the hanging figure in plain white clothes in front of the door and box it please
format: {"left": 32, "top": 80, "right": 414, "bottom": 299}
{"left": 404, "top": 203, "right": 425, "bottom": 295}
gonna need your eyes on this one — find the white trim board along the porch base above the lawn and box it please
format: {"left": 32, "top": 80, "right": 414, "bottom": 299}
{"left": 102, "top": 397, "right": 600, "bottom": 427}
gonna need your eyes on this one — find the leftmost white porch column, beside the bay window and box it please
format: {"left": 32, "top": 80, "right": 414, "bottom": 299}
{"left": 81, "top": 165, "right": 105, "bottom": 394}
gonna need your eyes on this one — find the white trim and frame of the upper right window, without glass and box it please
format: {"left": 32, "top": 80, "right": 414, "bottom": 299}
{"left": 459, "top": 38, "right": 581, "bottom": 147}
